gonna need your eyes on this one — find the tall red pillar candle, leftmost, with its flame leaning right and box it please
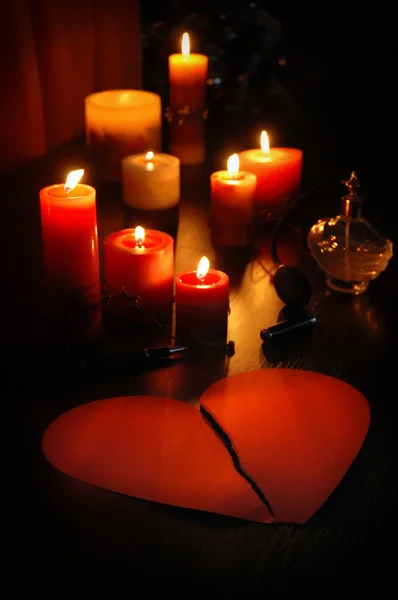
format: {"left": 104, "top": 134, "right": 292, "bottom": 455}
{"left": 40, "top": 169, "right": 101, "bottom": 311}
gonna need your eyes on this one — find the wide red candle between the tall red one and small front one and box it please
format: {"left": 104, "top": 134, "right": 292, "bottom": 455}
{"left": 104, "top": 227, "right": 174, "bottom": 319}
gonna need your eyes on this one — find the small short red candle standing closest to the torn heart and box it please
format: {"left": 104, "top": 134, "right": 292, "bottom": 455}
{"left": 175, "top": 256, "right": 229, "bottom": 341}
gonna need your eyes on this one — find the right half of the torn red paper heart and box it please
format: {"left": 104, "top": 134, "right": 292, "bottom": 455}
{"left": 201, "top": 369, "right": 370, "bottom": 523}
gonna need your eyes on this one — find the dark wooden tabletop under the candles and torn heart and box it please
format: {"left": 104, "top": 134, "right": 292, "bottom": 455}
{"left": 1, "top": 15, "right": 398, "bottom": 599}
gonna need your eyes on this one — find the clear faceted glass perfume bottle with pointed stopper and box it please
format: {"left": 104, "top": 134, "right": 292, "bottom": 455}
{"left": 308, "top": 171, "right": 393, "bottom": 294}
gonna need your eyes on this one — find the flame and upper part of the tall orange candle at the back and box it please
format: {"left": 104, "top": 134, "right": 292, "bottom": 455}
{"left": 169, "top": 33, "right": 209, "bottom": 112}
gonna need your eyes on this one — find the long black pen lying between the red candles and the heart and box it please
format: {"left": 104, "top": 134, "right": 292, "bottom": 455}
{"left": 78, "top": 346, "right": 188, "bottom": 373}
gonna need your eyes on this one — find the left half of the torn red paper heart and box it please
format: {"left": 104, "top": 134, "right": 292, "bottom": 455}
{"left": 42, "top": 396, "right": 273, "bottom": 523}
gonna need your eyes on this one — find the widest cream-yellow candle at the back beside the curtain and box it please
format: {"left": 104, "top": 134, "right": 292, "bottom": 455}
{"left": 85, "top": 90, "right": 162, "bottom": 180}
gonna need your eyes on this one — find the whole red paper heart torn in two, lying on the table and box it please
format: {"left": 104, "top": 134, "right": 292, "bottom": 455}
{"left": 42, "top": 369, "right": 370, "bottom": 523}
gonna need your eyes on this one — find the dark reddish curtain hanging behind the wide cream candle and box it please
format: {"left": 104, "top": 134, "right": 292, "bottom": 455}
{"left": 0, "top": 0, "right": 141, "bottom": 171}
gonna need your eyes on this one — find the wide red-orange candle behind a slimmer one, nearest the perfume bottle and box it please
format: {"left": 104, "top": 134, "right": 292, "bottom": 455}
{"left": 239, "top": 131, "right": 303, "bottom": 217}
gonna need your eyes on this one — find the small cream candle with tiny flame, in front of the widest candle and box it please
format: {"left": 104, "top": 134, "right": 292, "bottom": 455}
{"left": 122, "top": 151, "right": 180, "bottom": 210}
